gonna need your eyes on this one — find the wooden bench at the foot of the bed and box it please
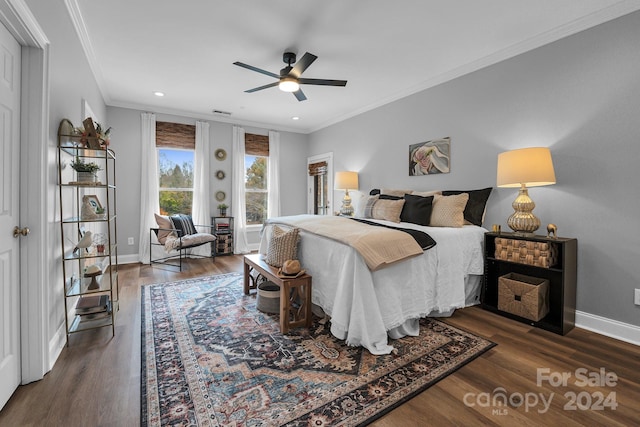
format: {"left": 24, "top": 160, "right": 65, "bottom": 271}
{"left": 244, "top": 254, "right": 311, "bottom": 334}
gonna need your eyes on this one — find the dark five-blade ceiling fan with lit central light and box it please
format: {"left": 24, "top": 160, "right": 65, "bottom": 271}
{"left": 233, "top": 52, "right": 347, "bottom": 101}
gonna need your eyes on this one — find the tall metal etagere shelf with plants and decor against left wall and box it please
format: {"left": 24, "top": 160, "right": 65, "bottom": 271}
{"left": 58, "top": 119, "right": 120, "bottom": 345}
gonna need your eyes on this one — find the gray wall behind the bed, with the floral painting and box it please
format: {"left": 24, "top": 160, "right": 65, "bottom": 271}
{"left": 309, "top": 12, "right": 640, "bottom": 326}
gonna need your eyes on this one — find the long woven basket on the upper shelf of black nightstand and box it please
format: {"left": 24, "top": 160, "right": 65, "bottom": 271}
{"left": 495, "top": 237, "right": 558, "bottom": 268}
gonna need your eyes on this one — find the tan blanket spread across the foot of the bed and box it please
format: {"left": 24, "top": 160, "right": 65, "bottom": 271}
{"left": 266, "top": 215, "right": 423, "bottom": 271}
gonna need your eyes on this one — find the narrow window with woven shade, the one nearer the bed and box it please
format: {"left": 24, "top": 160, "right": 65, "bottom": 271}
{"left": 244, "top": 133, "right": 269, "bottom": 225}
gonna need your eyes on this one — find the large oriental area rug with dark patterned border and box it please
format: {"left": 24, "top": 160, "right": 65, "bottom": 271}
{"left": 141, "top": 273, "right": 494, "bottom": 426}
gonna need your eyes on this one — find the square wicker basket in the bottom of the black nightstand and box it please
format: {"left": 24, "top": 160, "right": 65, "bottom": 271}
{"left": 498, "top": 273, "right": 549, "bottom": 322}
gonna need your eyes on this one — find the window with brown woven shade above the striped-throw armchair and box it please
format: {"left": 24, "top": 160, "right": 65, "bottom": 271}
{"left": 156, "top": 122, "right": 196, "bottom": 215}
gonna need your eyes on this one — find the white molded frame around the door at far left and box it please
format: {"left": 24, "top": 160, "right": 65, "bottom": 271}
{"left": 0, "top": 0, "right": 55, "bottom": 384}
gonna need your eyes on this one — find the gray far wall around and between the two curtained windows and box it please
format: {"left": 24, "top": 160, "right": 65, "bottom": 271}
{"left": 107, "top": 107, "right": 308, "bottom": 261}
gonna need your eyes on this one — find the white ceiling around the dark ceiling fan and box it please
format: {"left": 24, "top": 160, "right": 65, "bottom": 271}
{"left": 71, "top": 0, "right": 640, "bottom": 133}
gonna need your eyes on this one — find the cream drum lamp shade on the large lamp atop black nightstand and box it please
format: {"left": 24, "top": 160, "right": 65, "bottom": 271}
{"left": 497, "top": 147, "right": 556, "bottom": 188}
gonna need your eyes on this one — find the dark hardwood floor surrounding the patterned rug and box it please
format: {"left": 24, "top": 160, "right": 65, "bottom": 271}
{"left": 0, "top": 256, "right": 640, "bottom": 427}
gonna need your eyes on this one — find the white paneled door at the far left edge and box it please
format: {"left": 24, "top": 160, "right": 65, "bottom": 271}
{"left": 0, "top": 19, "right": 20, "bottom": 408}
